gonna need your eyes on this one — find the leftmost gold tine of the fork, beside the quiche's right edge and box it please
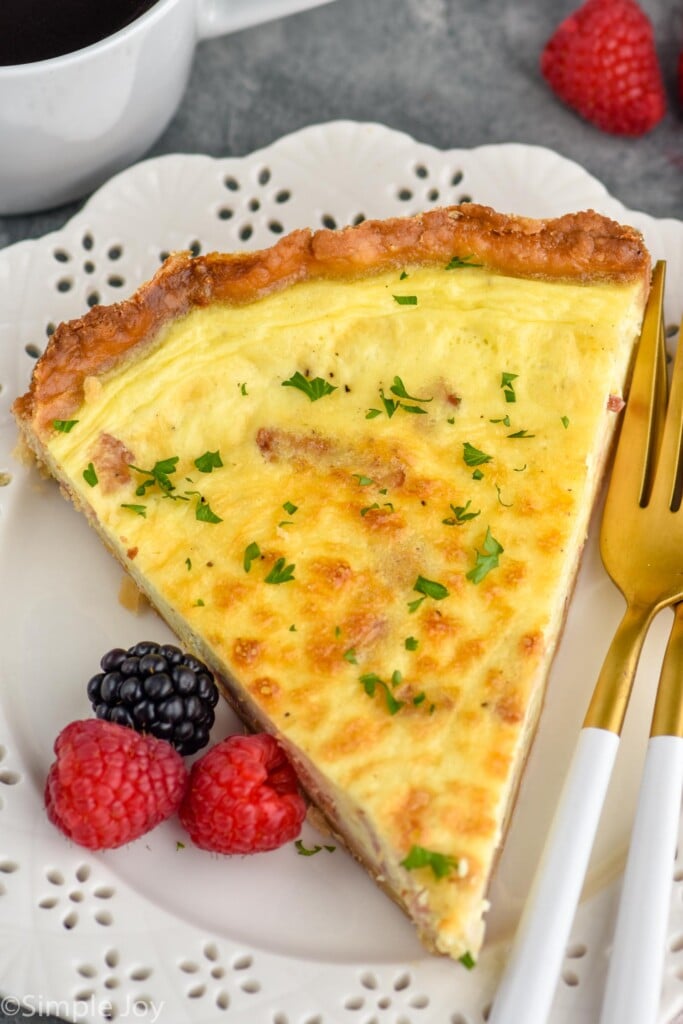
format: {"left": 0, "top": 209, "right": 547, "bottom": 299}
{"left": 603, "top": 260, "right": 667, "bottom": 522}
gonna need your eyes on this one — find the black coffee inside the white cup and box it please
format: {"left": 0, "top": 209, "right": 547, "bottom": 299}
{"left": 0, "top": 0, "right": 157, "bottom": 65}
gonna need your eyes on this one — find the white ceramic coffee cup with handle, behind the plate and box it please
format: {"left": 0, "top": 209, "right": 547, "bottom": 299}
{"left": 0, "top": 0, "right": 327, "bottom": 214}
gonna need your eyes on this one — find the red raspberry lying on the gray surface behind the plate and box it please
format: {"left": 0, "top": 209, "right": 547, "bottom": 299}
{"left": 541, "top": 0, "right": 667, "bottom": 135}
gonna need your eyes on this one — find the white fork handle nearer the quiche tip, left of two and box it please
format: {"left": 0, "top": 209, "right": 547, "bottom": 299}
{"left": 488, "top": 727, "right": 620, "bottom": 1024}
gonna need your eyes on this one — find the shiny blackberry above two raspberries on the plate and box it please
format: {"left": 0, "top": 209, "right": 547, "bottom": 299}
{"left": 88, "top": 640, "right": 218, "bottom": 754}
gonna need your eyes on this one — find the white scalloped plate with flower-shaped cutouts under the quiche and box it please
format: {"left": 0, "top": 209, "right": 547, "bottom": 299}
{"left": 0, "top": 122, "right": 683, "bottom": 1024}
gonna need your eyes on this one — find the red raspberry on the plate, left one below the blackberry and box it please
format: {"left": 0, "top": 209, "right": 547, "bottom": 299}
{"left": 45, "top": 718, "right": 187, "bottom": 850}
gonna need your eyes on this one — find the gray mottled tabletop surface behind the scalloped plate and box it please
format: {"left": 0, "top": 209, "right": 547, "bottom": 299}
{"left": 0, "top": 0, "right": 683, "bottom": 1024}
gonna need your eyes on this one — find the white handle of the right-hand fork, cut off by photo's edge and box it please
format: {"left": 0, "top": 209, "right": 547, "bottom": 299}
{"left": 600, "top": 736, "right": 683, "bottom": 1024}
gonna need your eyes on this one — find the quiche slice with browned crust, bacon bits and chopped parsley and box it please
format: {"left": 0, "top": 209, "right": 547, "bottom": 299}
{"left": 13, "top": 205, "right": 650, "bottom": 959}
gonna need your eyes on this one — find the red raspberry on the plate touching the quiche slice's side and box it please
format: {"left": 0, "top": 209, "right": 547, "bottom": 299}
{"left": 179, "top": 733, "right": 306, "bottom": 853}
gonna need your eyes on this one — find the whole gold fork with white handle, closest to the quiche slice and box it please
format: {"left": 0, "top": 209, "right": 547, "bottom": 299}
{"left": 488, "top": 262, "right": 683, "bottom": 1024}
